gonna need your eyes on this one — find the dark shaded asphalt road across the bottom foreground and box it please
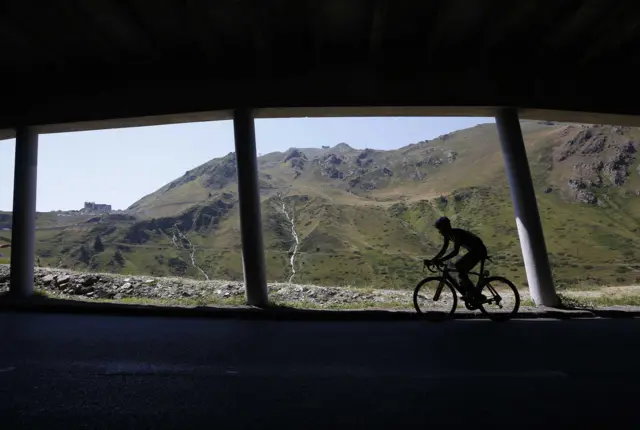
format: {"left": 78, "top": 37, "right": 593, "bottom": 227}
{"left": 0, "top": 313, "right": 640, "bottom": 429}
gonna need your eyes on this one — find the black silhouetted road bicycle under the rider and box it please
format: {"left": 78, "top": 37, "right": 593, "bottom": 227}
{"left": 413, "top": 256, "right": 520, "bottom": 321}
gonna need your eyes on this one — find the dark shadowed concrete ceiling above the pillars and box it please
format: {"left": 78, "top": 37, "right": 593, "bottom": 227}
{"left": 0, "top": 0, "right": 640, "bottom": 131}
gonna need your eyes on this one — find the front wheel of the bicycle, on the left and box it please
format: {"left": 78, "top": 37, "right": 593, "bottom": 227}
{"left": 413, "top": 277, "right": 458, "bottom": 319}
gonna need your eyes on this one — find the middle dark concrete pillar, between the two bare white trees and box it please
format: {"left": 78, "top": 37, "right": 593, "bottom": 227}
{"left": 233, "top": 109, "right": 268, "bottom": 307}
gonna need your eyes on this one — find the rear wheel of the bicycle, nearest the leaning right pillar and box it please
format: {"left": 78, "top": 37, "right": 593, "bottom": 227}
{"left": 479, "top": 276, "right": 520, "bottom": 321}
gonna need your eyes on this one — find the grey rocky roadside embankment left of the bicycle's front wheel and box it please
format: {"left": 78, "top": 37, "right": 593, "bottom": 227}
{"left": 0, "top": 265, "right": 412, "bottom": 308}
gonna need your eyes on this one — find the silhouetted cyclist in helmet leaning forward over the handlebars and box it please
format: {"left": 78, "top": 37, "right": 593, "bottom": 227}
{"left": 426, "top": 217, "right": 487, "bottom": 299}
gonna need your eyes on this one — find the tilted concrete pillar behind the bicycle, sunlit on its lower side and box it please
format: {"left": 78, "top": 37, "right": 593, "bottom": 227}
{"left": 496, "top": 108, "right": 559, "bottom": 306}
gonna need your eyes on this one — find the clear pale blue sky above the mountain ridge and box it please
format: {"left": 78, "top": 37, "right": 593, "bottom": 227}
{"left": 0, "top": 117, "right": 494, "bottom": 211}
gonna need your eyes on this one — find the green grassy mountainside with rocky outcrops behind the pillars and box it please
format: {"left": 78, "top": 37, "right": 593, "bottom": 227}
{"left": 0, "top": 122, "right": 640, "bottom": 288}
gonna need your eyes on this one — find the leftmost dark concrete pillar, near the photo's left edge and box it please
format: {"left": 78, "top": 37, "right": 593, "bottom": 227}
{"left": 10, "top": 127, "right": 38, "bottom": 297}
